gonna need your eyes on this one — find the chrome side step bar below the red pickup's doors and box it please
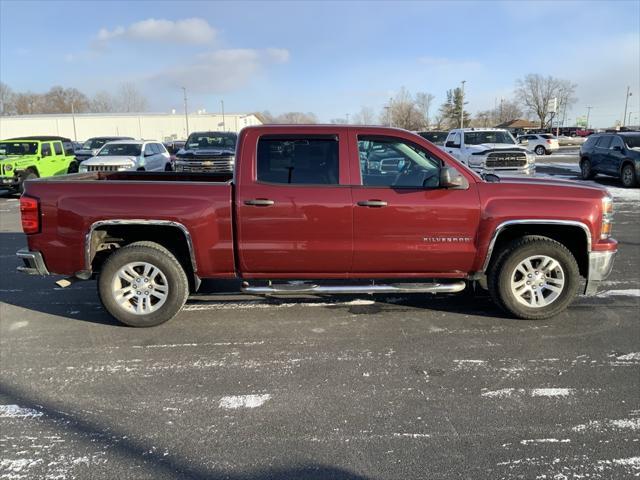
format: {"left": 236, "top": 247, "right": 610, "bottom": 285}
{"left": 242, "top": 281, "right": 466, "bottom": 295}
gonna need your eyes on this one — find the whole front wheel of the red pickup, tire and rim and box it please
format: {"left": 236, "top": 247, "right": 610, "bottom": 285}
{"left": 488, "top": 235, "right": 580, "bottom": 320}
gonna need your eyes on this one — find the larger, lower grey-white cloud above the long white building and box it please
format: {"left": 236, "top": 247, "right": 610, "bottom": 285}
{"left": 151, "top": 48, "right": 289, "bottom": 93}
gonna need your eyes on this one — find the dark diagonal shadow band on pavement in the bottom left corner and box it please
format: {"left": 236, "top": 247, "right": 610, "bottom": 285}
{"left": 0, "top": 383, "right": 368, "bottom": 480}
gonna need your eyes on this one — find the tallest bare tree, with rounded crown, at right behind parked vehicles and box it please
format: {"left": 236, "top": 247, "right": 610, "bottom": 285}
{"left": 516, "top": 73, "right": 577, "bottom": 128}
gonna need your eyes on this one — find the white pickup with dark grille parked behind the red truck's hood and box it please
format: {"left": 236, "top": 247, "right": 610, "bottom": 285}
{"left": 444, "top": 128, "right": 536, "bottom": 175}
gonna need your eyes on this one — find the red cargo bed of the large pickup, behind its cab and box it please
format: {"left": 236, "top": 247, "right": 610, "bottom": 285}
{"left": 25, "top": 172, "right": 235, "bottom": 278}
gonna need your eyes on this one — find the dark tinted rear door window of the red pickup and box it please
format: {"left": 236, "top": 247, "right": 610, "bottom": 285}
{"left": 257, "top": 136, "right": 339, "bottom": 185}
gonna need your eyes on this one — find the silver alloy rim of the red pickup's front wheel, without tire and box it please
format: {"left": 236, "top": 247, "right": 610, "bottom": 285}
{"left": 511, "top": 255, "right": 565, "bottom": 308}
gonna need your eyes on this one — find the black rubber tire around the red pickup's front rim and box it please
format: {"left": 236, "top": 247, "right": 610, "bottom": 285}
{"left": 488, "top": 235, "right": 580, "bottom": 320}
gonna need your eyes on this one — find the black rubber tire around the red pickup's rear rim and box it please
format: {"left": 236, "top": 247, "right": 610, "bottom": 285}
{"left": 98, "top": 242, "right": 189, "bottom": 327}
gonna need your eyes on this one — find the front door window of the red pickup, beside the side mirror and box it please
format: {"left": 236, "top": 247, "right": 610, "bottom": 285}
{"left": 358, "top": 136, "right": 441, "bottom": 188}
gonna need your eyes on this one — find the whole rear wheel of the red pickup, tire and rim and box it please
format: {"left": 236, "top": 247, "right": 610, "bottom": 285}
{"left": 98, "top": 242, "right": 189, "bottom": 327}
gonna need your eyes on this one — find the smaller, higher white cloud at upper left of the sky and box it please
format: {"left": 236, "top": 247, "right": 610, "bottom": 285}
{"left": 93, "top": 18, "right": 217, "bottom": 48}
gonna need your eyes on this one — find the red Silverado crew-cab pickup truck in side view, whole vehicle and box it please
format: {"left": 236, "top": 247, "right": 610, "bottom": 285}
{"left": 18, "top": 126, "right": 617, "bottom": 326}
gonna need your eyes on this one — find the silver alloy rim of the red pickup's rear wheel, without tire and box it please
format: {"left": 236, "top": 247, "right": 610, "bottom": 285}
{"left": 111, "top": 262, "right": 169, "bottom": 315}
